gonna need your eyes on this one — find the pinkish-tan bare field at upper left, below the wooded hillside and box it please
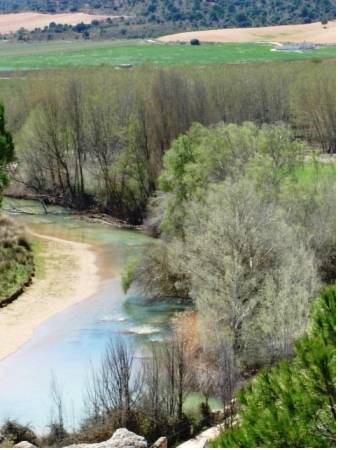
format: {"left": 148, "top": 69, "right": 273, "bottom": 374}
{"left": 0, "top": 12, "right": 112, "bottom": 34}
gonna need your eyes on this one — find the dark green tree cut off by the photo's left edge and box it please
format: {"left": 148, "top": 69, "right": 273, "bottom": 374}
{"left": 0, "top": 104, "right": 14, "bottom": 206}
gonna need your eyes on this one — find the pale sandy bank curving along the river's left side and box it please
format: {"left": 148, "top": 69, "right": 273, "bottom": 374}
{"left": 0, "top": 233, "right": 100, "bottom": 359}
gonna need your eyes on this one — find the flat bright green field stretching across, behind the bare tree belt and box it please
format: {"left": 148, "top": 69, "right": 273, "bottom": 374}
{"left": 0, "top": 41, "right": 336, "bottom": 71}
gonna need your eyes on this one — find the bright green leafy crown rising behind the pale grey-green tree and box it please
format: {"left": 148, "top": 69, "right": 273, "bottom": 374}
{"left": 159, "top": 122, "right": 304, "bottom": 235}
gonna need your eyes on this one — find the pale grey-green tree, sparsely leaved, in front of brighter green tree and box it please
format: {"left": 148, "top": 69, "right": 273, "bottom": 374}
{"left": 178, "top": 179, "right": 317, "bottom": 367}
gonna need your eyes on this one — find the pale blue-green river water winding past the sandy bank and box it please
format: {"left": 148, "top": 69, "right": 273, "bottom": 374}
{"left": 0, "top": 199, "right": 184, "bottom": 432}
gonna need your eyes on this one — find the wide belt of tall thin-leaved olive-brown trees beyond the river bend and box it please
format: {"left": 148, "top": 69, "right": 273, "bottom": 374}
{"left": 1, "top": 63, "right": 335, "bottom": 224}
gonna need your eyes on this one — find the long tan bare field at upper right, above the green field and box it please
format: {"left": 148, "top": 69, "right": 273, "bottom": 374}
{"left": 160, "top": 22, "right": 336, "bottom": 44}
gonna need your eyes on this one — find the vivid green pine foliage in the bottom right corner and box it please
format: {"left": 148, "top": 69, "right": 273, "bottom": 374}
{"left": 212, "top": 287, "right": 336, "bottom": 448}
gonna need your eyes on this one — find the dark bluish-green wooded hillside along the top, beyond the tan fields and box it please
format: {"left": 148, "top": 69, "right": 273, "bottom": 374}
{"left": 0, "top": 0, "right": 335, "bottom": 37}
